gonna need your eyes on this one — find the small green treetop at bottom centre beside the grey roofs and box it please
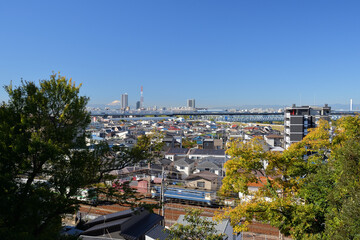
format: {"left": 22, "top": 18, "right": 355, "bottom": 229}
{"left": 167, "top": 209, "right": 225, "bottom": 240}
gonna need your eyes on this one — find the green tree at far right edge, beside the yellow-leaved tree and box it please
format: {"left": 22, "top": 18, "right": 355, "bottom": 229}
{"left": 325, "top": 116, "right": 360, "bottom": 239}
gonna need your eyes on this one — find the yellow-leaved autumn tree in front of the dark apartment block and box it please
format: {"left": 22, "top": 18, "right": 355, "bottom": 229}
{"left": 215, "top": 122, "right": 330, "bottom": 237}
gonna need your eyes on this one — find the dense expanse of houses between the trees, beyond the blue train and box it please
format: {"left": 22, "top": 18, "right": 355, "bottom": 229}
{"left": 87, "top": 117, "right": 284, "bottom": 196}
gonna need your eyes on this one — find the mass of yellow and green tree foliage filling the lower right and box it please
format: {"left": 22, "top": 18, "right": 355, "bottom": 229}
{"left": 218, "top": 116, "right": 360, "bottom": 239}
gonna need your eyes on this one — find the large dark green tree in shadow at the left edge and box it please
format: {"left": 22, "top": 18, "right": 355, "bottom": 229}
{"left": 0, "top": 74, "right": 156, "bottom": 239}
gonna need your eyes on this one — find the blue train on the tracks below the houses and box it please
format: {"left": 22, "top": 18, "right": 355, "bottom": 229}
{"left": 151, "top": 186, "right": 216, "bottom": 206}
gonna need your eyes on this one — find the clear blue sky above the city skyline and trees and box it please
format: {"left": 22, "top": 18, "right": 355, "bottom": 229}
{"left": 0, "top": 0, "right": 360, "bottom": 107}
